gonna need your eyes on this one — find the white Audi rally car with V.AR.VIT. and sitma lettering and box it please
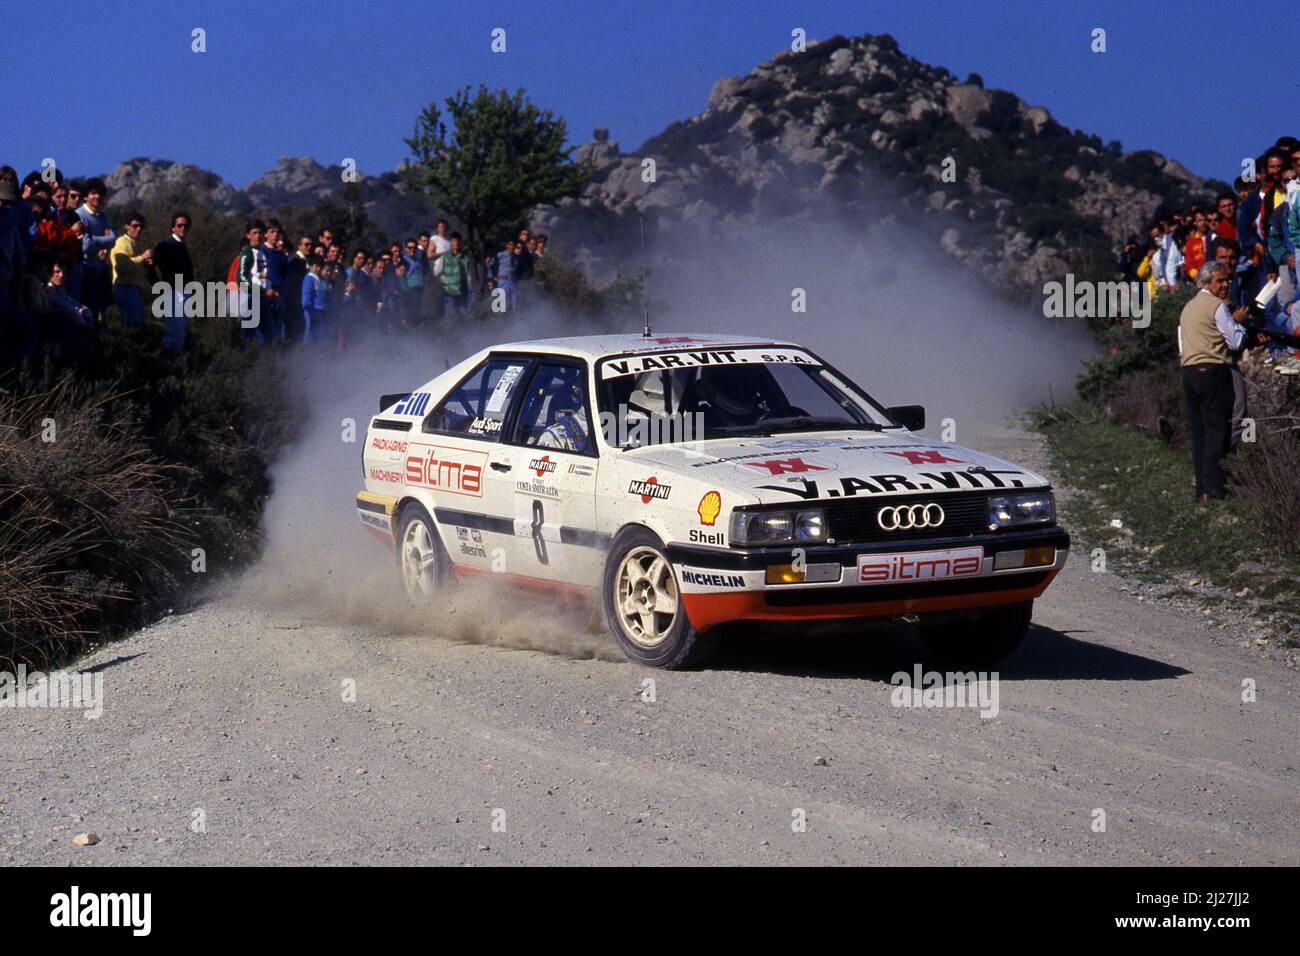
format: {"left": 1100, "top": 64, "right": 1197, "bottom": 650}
{"left": 356, "top": 334, "right": 1070, "bottom": 667}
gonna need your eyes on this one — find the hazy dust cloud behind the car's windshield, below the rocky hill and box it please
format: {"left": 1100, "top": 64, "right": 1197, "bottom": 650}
{"left": 629, "top": 209, "right": 1095, "bottom": 446}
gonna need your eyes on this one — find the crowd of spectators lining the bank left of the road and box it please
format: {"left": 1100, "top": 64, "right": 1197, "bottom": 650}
{"left": 0, "top": 166, "right": 546, "bottom": 371}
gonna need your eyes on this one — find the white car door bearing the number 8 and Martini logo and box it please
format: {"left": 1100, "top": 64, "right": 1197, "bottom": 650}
{"left": 506, "top": 356, "right": 605, "bottom": 587}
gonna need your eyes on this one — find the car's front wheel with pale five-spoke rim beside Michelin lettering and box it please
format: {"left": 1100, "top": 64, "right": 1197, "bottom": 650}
{"left": 602, "top": 527, "right": 716, "bottom": 670}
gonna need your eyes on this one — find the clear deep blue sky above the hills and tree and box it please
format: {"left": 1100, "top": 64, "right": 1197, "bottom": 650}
{"left": 0, "top": 0, "right": 1274, "bottom": 186}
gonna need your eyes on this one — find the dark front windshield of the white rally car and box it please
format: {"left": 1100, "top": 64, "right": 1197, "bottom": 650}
{"left": 599, "top": 351, "right": 894, "bottom": 447}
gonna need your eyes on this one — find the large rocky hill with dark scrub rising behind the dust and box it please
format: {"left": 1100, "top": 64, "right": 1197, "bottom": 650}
{"left": 538, "top": 35, "right": 1222, "bottom": 294}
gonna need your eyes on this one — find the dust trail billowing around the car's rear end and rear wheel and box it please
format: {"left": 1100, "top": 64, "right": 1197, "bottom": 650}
{"left": 239, "top": 316, "right": 621, "bottom": 659}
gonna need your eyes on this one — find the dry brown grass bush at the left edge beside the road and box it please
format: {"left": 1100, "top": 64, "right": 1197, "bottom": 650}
{"left": 0, "top": 378, "right": 192, "bottom": 670}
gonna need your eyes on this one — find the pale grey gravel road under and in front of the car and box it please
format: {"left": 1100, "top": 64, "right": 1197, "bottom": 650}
{"left": 0, "top": 431, "right": 1300, "bottom": 865}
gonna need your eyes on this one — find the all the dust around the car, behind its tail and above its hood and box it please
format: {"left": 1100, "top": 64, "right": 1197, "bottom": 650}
{"left": 241, "top": 195, "right": 1091, "bottom": 659}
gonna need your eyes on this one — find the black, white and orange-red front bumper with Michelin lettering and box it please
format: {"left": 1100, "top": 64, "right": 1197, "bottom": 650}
{"left": 667, "top": 527, "right": 1070, "bottom": 631}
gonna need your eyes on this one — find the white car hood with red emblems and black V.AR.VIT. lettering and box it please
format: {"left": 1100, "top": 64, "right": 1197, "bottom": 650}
{"left": 624, "top": 429, "right": 1049, "bottom": 505}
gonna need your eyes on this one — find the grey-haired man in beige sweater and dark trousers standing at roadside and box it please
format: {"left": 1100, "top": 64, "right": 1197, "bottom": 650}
{"left": 1178, "top": 261, "right": 1262, "bottom": 501}
